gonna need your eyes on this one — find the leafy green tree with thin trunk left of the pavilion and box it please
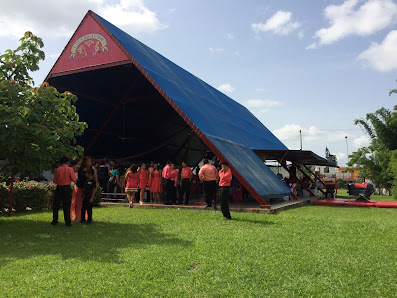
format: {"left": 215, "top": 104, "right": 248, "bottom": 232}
{"left": 0, "top": 32, "right": 87, "bottom": 212}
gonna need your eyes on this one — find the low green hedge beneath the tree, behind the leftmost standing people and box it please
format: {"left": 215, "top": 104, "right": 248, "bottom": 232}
{"left": 0, "top": 182, "right": 102, "bottom": 212}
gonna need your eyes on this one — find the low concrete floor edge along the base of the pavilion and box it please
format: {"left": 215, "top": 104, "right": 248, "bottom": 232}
{"left": 101, "top": 198, "right": 316, "bottom": 214}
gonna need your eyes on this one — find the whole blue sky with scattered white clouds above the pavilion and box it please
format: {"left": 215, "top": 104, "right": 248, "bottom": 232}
{"left": 0, "top": 0, "right": 397, "bottom": 165}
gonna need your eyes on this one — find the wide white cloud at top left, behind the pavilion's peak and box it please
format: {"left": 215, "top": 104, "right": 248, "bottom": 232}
{"left": 0, "top": 0, "right": 165, "bottom": 38}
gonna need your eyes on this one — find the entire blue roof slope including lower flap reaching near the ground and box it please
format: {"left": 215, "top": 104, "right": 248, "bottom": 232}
{"left": 96, "top": 15, "right": 291, "bottom": 198}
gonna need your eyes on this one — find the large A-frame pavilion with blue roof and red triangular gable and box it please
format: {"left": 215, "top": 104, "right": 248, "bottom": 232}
{"left": 46, "top": 11, "right": 328, "bottom": 207}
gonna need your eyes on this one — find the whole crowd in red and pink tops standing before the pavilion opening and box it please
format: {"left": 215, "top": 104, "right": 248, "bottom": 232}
{"left": 51, "top": 156, "right": 232, "bottom": 226}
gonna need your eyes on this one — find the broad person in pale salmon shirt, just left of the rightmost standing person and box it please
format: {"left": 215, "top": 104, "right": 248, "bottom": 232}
{"left": 199, "top": 159, "right": 219, "bottom": 209}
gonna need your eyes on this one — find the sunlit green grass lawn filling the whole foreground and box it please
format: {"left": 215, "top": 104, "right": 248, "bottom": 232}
{"left": 0, "top": 206, "right": 397, "bottom": 297}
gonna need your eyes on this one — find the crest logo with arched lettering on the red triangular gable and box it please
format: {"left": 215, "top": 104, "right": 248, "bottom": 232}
{"left": 69, "top": 33, "right": 109, "bottom": 60}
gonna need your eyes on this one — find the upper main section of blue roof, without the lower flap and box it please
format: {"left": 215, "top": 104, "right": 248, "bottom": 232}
{"left": 97, "top": 15, "right": 288, "bottom": 150}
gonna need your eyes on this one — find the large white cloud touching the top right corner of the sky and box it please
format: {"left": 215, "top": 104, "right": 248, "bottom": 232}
{"left": 308, "top": 0, "right": 397, "bottom": 49}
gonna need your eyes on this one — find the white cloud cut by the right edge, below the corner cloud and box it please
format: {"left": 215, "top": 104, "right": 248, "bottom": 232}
{"left": 358, "top": 30, "right": 397, "bottom": 72}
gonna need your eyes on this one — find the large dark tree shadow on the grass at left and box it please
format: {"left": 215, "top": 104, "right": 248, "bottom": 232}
{"left": 0, "top": 218, "right": 192, "bottom": 268}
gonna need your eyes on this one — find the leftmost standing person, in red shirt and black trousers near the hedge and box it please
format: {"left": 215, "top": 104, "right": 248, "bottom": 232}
{"left": 51, "top": 156, "right": 81, "bottom": 227}
